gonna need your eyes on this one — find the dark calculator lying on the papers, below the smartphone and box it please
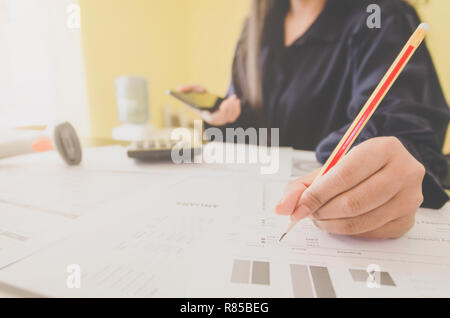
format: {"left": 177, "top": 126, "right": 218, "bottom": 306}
{"left": 127, "top": 138, "right": 202, "bottom": 162}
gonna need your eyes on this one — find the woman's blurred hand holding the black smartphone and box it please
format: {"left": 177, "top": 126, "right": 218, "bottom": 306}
{"left": 178, "top": 85, "right": 241, "bottom": 126}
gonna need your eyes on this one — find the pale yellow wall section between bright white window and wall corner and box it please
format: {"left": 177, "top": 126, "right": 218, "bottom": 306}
{"left": 79, "top": 0, "right": 188, "bottom": 137}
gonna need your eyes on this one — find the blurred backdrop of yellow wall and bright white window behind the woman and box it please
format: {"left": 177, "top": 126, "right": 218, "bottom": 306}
{"left": 0, "top": 0, "right": 450, "bottom": 148}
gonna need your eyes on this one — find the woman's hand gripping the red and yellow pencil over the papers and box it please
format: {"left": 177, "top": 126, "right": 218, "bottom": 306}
{"left": 275, "top": 137, "right": 425, "bottom": 238}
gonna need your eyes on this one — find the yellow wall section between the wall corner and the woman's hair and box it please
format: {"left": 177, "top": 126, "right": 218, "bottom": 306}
{"left": 188, "top": 0, "right": 250, "bottom": 94}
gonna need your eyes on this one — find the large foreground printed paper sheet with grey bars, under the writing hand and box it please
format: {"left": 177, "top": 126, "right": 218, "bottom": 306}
{"left": 0, "top": 148, "right": 450, "bottom": 297}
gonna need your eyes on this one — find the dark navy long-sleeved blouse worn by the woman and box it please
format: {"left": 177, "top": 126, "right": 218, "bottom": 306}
{"left": 223, "top": 0, "right": 450, "bottom": 208}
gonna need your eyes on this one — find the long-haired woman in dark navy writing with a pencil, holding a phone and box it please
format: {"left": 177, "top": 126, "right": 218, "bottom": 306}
{"left": 180, "top": 0, "right": 449, "bottom": 238}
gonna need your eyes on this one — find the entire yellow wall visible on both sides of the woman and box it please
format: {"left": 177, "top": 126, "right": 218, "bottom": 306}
{"left": 79, "top": 0, "right": 450, "bottom": 152}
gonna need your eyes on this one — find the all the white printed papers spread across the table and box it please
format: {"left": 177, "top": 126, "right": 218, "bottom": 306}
{"left": 0, "top": 147, "right": 450, "bottom": 297}
